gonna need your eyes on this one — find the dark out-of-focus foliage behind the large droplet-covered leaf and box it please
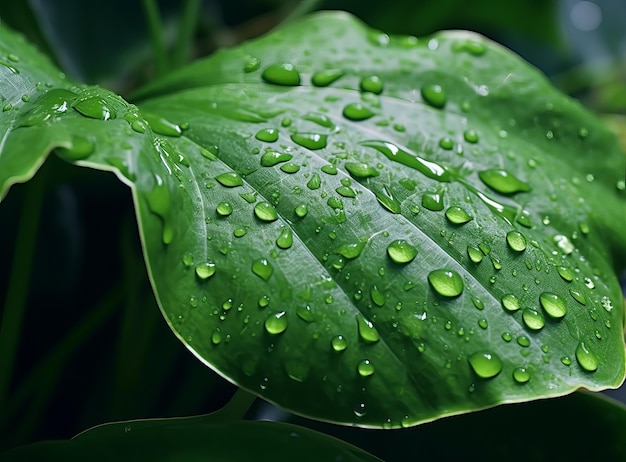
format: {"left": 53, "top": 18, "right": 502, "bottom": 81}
{"left": 0, "top": 0, "right": 626, "bottom": 450}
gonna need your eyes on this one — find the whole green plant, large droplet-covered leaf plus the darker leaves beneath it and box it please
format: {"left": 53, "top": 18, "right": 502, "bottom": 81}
{"left": 0, "top": 2, "right": 626, "bottom": 460}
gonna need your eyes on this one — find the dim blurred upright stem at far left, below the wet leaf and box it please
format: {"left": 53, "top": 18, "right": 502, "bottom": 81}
{"left": 0, "top": 168, "right": 47, "bottom": 428}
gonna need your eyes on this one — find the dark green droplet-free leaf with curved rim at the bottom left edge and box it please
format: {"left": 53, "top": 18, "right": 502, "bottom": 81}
{"left": 3, "top": 417, "right": 380, "bottom": 462}
